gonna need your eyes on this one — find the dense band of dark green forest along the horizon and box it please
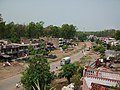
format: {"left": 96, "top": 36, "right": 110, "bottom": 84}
{"left": 0, "top": 14, "right": 116, "bottom": 42}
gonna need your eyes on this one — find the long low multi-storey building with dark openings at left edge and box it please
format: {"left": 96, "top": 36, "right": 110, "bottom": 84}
{"left": 0, "top": 40, "right": 40, "bottom": 61}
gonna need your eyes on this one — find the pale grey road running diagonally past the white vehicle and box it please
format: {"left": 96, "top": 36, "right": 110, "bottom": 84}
{"left": 0, "top": 42, "right": 90, "bottom": 90}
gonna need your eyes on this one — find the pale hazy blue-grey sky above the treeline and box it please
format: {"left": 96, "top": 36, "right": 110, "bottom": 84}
{"left": 0, "top": 0, "right": 120, "bottom": 31}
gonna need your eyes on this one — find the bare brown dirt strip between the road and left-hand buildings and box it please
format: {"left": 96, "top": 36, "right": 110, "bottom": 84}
{"left": 0, "top": 42, "right": 84, "bottom": 80}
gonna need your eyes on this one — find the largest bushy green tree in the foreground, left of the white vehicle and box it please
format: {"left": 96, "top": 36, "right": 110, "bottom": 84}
{"left": 21, "top": 56, "right": 53, "bottom": 90}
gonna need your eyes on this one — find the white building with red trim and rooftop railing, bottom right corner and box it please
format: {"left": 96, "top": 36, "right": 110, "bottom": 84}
{"left": 82, "top": 67, "right": 120, "bottom": 90}
